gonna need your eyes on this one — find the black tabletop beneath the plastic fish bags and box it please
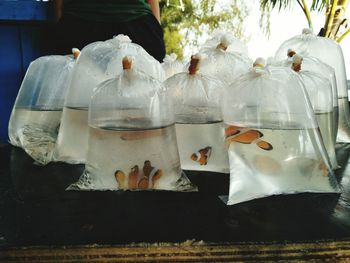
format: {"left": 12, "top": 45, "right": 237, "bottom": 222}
{"left": 0, "top": 144, "right": 350, "bottom": 249}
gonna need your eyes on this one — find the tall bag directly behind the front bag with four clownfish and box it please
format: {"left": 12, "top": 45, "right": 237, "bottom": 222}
{"left": 54, "top": 35, "right": 164, "bottom": 164}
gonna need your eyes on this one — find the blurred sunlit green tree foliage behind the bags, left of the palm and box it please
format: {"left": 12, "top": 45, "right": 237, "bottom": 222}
{"left": 159, "top": 0, "right": 248, "bottom": 59}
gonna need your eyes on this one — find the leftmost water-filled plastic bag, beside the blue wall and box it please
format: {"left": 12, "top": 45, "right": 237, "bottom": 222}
{"left": 8, "top": 49, "right": 79, "bottom": 165}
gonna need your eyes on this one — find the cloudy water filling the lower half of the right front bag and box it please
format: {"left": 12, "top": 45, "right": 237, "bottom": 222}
{"left": 228, "top": 124, "right": 337, "bottom": 205}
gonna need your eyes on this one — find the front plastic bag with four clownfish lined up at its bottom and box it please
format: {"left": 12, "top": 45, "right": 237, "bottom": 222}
{"left": 68, "top": 56, "right": 196, "bottom": 191}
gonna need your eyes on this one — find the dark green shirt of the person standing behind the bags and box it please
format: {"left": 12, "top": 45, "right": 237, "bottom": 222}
{"left": 63, "top": 0, "right": 152, "bottom": 23}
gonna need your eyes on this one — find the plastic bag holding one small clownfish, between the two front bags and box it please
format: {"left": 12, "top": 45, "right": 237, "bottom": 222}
{"left": 164, "top": 54, "right": 229, "bottom": 173}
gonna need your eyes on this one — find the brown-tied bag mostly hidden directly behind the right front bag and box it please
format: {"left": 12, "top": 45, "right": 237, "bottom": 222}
{"left": 292, "top": 54, "right": 339, "bottom": 170}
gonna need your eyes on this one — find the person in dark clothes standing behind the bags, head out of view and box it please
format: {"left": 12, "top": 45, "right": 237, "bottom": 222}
{"left": 54, "top": 0, "right": 166, "bottom": 62}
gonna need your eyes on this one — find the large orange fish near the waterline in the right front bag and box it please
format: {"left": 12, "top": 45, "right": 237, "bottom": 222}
{"left": 225, "top": 126, "right": 273, "bottom": 151}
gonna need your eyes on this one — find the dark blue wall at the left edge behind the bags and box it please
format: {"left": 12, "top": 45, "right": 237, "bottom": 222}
{"left": 0, "top": 0, "right": 53, "bottom": 143}
